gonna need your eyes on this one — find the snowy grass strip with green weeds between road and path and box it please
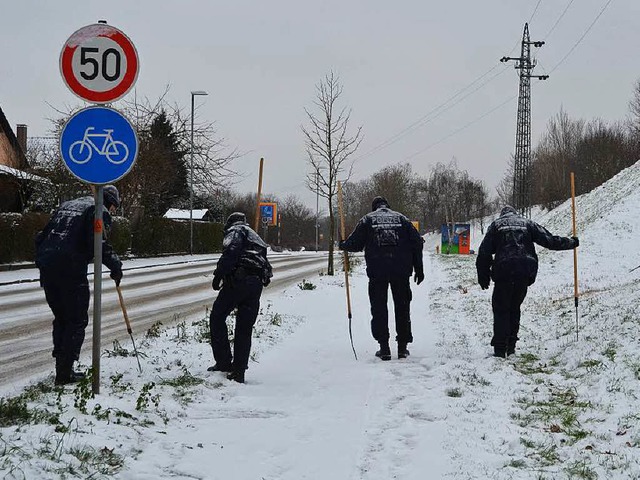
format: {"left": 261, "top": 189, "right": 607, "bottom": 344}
{"left": 0, "top": 301, "right": 308, "bottom": 479}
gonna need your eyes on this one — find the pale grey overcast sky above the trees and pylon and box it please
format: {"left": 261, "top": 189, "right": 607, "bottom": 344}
{"left": 0, "top": 0, "right": 640, "bottom": 207}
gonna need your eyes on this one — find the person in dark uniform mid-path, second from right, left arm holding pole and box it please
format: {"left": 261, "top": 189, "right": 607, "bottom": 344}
{"left": 339, "top": 197, "right": 424, "bottom": 360}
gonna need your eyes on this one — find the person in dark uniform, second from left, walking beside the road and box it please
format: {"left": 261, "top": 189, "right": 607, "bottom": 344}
{"left": 208, "top": 212, "right": 273, "bottom": 383}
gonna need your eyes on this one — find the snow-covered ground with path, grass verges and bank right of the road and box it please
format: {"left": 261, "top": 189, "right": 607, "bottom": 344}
{"left": 0, "top": 164, "right": 640, "bottom": 480}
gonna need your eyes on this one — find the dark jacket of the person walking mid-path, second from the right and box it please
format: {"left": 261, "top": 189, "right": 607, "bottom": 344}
{"left": 340, "top": 206, "right": 424, "bottom": 278}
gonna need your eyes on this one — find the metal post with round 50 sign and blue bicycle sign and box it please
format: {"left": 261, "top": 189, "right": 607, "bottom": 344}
{"left": 60, "top": 21, "right": 140, "bottom": 394}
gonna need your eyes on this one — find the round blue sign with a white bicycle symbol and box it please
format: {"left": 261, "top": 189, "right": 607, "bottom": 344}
{"left": 60, "top": 107, "right": 138, "bottom": 185}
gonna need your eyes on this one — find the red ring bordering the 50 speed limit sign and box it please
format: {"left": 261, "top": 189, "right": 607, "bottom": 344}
{"left": 60, "top": 27, "right": 138, "bottom": 103}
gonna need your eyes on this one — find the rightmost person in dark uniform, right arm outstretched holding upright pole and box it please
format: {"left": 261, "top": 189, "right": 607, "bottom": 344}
{"left": 476, "top": 206, "right": 579, "bottom": 358}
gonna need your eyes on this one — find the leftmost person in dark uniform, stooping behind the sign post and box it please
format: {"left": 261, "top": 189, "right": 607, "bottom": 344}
{"left": 36, "top": 185, "right": 122, "bottom": 385}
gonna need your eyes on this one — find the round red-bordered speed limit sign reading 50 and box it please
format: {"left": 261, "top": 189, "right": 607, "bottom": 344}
{"left": 60, "top": 23, "right": 139, "bottom": 103}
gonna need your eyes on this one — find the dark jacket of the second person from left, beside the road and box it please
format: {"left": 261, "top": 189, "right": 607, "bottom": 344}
{"left": 213, "top": 222, "right": 273, "bottom": 283}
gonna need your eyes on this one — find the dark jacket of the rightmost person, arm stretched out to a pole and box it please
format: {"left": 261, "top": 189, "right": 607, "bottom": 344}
{"left": 476, "top": 207, "right": 575, "bottom": 286}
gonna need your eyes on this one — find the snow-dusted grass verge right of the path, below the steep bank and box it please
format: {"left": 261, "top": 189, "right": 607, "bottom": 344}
{"left": 430, "top": 253, "right": 640, "bottom": 479}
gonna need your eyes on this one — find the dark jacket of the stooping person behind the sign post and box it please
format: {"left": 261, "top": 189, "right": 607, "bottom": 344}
{"left": 36, "top": 196, "right": 122, "bottom": 277}
